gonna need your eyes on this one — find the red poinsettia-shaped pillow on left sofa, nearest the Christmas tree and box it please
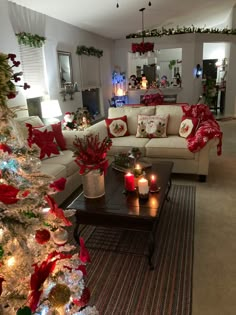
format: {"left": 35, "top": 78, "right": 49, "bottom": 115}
{"left": 31, "top": 126, "right": 60, "bottom": 160}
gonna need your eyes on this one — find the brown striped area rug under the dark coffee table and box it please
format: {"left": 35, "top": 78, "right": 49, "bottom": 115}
{"left": 83, "top": 185, "right": 196, "bottom": 315}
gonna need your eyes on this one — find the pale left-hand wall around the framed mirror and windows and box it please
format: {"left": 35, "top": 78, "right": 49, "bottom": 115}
{"left": 0, "top": 0, "right": 113, "bottom": 118}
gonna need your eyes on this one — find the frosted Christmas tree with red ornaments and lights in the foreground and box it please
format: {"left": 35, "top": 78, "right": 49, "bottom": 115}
{"left": 0, "top": 53, "right": 98, "bottom": 315}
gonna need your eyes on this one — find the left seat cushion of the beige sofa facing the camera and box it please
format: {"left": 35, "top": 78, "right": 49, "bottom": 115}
{"left": 107, "top": 135, "right": 149, "bottom": 156}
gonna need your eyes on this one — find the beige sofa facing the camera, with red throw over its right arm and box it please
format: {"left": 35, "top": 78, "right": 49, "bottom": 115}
{"left": 86, "top": 104, "right": 219, "bottom": 181}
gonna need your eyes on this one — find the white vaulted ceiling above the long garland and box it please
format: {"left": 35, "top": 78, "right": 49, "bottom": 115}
{"left": 8, "top": 0, "right": 236, "bottom": 39}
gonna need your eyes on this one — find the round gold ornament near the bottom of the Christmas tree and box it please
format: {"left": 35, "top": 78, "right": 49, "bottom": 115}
{"left": 48, "top": 283, "right": 71, "bottom": 307}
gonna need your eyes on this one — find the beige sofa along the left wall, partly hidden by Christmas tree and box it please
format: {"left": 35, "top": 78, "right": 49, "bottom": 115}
{"left": 16, "top": 116, "right": 84, "bottom": 205}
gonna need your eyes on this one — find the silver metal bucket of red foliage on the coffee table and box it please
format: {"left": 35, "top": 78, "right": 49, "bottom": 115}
{"left": 74, "top": 134, "right": 112, "bottom": 198}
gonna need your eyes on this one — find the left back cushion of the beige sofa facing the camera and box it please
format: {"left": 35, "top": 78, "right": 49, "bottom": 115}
{"left": 108, "top": 106, "right": 155, "bottom": 135}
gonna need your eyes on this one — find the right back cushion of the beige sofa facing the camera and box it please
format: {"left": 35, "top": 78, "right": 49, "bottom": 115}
{"left": 156, "top": 104, "right": 183, "bottom": 135}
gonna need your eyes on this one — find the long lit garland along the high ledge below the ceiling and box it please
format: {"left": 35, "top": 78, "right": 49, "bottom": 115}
{"left": 126, "top": 25, "right": 236, "bottom": 39}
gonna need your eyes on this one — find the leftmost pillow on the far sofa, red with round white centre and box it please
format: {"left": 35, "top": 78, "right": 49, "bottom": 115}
{"left": 105, "top": 115, "right": 129, "bottom": 138}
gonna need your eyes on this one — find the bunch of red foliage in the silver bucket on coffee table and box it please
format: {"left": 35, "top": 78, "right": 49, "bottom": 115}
{"left": 74, "top": 134, "right": 112, "bottom": 175}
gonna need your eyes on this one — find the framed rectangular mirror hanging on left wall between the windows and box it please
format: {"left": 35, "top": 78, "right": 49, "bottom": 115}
{"left": 57, "top": 51, "right": 73, "bottom": 88}
